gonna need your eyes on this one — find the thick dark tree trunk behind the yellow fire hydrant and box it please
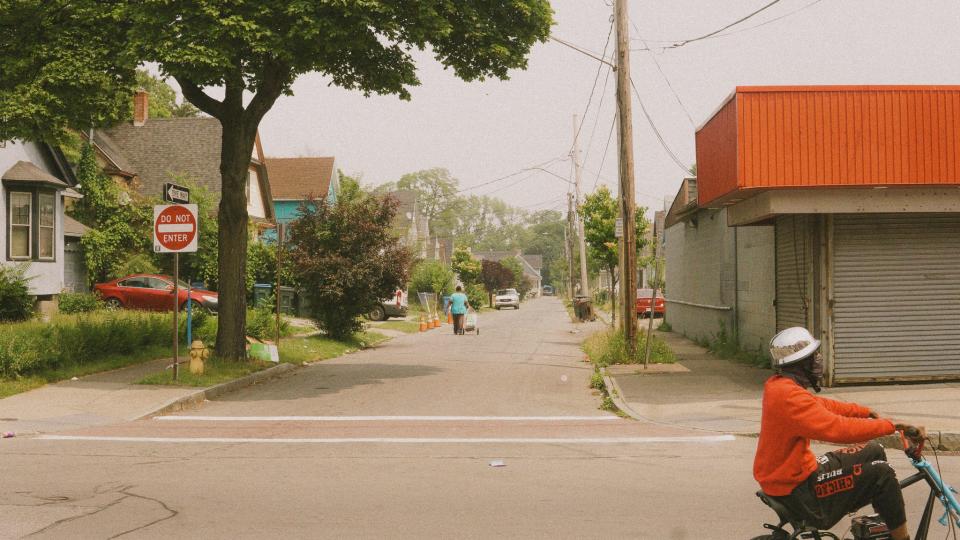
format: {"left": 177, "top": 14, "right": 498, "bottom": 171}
{"left": 216, "top": 116, "right": 256, "bottom": 361}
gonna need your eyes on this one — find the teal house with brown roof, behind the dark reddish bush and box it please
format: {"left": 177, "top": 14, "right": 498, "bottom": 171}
{"left": 263, "top": 157, "right": 340, "bottom": 241}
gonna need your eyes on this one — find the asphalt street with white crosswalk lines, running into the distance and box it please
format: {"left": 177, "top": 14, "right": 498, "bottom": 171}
{"left": 0, "top": 298, "right": 960, "bottom": 539}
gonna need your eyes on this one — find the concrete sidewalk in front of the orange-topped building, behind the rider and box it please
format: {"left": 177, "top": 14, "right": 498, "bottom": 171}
{"left": 607, "top": 332, "right": 960, "bottom": 450}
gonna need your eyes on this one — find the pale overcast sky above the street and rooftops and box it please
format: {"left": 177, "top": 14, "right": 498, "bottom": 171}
{"left": 253, "top": 0, "right": 960, "bottom": 217}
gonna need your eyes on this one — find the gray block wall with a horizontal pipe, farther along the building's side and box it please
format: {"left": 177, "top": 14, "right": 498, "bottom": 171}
{"left": 664, "top": 210, "right": 735, "bottom": 339}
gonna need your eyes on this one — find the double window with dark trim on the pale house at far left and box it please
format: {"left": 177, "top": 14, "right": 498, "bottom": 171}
{"left": 7, "top": 190, "right": 57, "bottom": 261}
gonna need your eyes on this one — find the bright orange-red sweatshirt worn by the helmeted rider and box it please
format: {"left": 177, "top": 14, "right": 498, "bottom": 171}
{"left": 753, "top": 375, "right": 894, "bottom": 496}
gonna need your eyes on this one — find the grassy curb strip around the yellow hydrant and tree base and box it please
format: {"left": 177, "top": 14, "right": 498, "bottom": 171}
{"left": 137, "top": 332, "right": 389, "bottom": 387}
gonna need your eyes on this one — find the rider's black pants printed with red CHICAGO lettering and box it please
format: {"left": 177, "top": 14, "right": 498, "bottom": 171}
{"left": 772, "top": 442, "right": 907, "bottom": 530}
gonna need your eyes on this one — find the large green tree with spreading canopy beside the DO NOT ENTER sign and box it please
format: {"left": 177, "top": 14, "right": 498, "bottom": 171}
{"left": 0, "top": 0, "right": 552, "bottom": 358}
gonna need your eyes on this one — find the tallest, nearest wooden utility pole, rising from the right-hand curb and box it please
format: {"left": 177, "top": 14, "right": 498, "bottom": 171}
{"left": 614, "top": 0, "right": 637, "bottom": 358}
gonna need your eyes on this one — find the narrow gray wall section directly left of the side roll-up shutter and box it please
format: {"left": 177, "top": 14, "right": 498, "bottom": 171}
{"left": 736, "top": 225, "right": 777, "bottom": 350}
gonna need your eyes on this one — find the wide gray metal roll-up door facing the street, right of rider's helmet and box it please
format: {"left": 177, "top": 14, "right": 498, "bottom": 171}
{"left": 833, "top": 214, "right": 960, "bottom": 382}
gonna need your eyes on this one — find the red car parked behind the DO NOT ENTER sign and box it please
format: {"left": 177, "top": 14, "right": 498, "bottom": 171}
{"left": 93, "top": 274, "right": 218, "bottom": 313}
